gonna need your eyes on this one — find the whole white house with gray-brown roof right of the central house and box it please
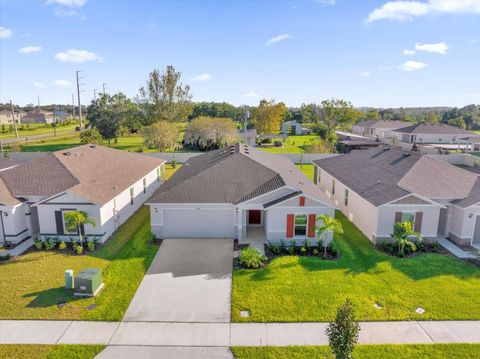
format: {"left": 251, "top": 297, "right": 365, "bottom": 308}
{"left": 313, "top": 148, "right": 480, "bottom": 245}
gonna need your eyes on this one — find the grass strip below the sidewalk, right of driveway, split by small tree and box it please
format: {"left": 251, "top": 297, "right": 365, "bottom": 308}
{"left": 232, "top": 344, "right": 480, "bottom": 359}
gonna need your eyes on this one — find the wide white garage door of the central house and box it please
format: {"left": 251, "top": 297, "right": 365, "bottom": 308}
{"left": 163, "top": 208, "right": 234, "bottom": 238}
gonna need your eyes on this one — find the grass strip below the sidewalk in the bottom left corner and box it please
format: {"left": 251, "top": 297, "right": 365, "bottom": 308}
{"left": 0, "top": 344, "right": 105, "bottom": 359}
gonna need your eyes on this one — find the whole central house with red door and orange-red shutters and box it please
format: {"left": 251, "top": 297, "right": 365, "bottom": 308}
{"left": 148, "top": 144, "right": 335, "bottom": 243}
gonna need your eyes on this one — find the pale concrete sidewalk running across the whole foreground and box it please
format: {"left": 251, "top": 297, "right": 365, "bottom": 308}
{"left": 0, "top": 320, "right": 480, "bottom": 348}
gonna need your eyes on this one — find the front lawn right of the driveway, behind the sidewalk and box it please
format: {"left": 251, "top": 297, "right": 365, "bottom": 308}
{"left": 232, "top": 211, "right": 480, "bottom": 322}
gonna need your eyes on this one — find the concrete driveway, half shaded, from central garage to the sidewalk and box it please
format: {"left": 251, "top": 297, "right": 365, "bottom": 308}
{"left": 123, "top": 238, "right": 233, "bottom": 323}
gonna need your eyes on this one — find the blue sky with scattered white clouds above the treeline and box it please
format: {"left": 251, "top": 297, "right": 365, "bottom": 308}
{"left": 0, "top": 0, "right": 480, "bottom": 107}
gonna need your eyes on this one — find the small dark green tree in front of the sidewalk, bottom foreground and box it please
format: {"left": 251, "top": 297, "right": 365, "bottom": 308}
{"left": 326, "top": 299, "right": 360, "bottom": 359}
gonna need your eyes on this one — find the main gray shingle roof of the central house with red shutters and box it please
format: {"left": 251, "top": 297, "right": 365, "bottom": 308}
{"left": 149, "top": 144, "right": 330, "bottom": 204}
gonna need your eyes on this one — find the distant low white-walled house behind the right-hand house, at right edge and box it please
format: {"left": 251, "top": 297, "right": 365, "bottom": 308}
{"left": 393, "top": 123, "right": 477, "bottom": 144}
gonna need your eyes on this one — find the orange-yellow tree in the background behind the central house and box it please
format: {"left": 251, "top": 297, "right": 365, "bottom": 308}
{"left": 252, "top": 100, "right": 287, "bottom": 134}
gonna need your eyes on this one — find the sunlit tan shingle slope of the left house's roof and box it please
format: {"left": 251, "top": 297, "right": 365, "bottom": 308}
{"left": 54, "top": 145, "right": 165, "bottom": 204}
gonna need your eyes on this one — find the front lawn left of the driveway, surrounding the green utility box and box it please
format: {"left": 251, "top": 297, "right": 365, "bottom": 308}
{"left": 0, "top": 206, "right": 158, "bottom": 321}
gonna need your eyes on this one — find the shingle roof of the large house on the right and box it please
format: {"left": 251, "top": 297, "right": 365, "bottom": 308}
{"left": 314, "top": 148, "right": 476, "bottom": 206}
